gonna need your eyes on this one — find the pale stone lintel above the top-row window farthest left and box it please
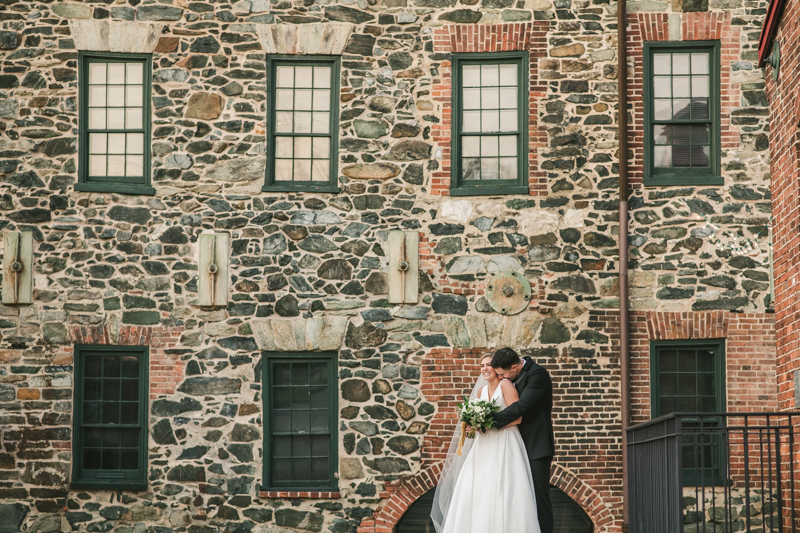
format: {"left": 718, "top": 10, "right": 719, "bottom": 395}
{"left": 69, "top": 19, "right": 164, "bottom": 54}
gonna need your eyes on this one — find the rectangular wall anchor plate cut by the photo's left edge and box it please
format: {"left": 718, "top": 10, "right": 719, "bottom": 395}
{"left": 3, "top": 231, "right": 33, "bottom": 304}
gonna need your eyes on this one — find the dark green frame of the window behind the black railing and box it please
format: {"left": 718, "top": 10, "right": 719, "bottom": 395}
{"left": 650, "top": 339, "right": 727, "bottom": 487}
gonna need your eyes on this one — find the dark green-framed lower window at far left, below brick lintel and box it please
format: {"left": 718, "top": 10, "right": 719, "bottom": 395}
{"left": 71, "top": 345, "right": 149, "bottom": 489}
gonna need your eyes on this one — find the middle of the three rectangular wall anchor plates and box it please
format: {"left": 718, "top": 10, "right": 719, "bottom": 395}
{"left": 197, "top": 233, "right": 230, "bottom": 306}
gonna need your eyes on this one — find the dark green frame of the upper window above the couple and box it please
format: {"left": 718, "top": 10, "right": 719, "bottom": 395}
{"left": 450, "top": 51, "right": 530, "bottom": 196}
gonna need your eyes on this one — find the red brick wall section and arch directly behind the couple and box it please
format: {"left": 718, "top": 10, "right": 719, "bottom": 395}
{"left": 358, "top": 338, "right": 622, "bottom": 533}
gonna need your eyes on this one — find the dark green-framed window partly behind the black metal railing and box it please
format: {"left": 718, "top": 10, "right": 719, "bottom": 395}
{"left": 650, "top": 339, "right": 726, "bottom": 485}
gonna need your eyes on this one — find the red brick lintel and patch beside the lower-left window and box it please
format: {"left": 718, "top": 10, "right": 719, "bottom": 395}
{"left": 69, "top": 326, "right": 185, "bottom": 399}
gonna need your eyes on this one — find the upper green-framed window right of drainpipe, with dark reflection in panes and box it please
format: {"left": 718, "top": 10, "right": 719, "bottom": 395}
{"left": 644, "top": 41, "right": 723, "bottom": 185}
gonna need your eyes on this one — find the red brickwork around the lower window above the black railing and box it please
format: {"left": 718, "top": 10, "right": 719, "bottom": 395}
{"left": 630, "top": 311, "right": 778, "bottom": 424}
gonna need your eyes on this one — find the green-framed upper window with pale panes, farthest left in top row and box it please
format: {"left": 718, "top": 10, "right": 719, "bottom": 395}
{"left": 75, "top": 52, "right": 155, "bottom": 194}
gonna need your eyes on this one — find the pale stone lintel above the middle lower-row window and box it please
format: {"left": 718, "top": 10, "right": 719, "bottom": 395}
{"left": 250, "top": 316, "right": 349, "bottom": 352}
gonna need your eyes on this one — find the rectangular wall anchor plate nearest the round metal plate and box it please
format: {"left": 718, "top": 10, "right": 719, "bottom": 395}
{"left": 388, "top": 231, "right": 419, "bottom": 304}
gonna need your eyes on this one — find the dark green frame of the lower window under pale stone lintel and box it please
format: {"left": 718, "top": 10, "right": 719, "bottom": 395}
{"left": 261, "top": 352, "right": 339, "bottom": 492}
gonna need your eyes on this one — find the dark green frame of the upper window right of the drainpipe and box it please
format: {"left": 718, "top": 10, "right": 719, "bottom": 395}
{"left": 643, "top": 41, "right": 725, "bottom": 186}
